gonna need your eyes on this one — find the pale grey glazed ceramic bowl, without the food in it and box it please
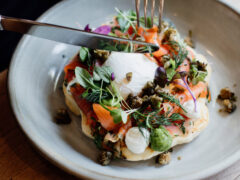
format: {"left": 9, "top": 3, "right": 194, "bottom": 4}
{"left": 9, "top": 0, "right": 240, "bottom": 179}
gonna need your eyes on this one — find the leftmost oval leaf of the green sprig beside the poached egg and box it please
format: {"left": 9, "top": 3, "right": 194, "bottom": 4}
{"left": 75, "top": 67, "right": 96, "bottom": 89}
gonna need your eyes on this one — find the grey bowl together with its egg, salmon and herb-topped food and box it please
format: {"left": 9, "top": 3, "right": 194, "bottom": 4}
{"left": 9, "top": 0, "right": 240, "bottom": 179}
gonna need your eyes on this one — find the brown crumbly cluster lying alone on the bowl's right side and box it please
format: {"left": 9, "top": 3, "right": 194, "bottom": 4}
{"left": 218, "top": 88, "right": 237, "bottom": 113}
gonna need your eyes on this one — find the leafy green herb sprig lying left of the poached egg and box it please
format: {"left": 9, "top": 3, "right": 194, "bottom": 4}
{"left": 75, "top": 66, "right": 128, "bottom": 124}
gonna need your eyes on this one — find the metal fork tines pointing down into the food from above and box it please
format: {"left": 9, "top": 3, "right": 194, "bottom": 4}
{"left": 135, "top": 0, "right": 164, "bottom": 32}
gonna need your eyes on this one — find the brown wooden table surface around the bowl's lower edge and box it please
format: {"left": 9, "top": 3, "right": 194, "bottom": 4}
{"left": 0, "top": 70, "right": 240, "bottom": 180}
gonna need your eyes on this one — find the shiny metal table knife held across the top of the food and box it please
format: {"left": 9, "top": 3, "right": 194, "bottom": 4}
{"left": 0, "top": 15, "right": 159, "bottom": 53}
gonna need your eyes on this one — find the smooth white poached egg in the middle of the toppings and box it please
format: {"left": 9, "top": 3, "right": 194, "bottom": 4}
{"left": 103, "top": 52, "right": 158, "bottom": 99}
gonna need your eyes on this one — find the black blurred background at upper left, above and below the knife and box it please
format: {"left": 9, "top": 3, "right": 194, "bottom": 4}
{"left": 0, "top": 0, "right": 60, "bottom": 71}
